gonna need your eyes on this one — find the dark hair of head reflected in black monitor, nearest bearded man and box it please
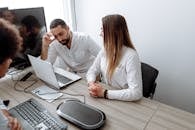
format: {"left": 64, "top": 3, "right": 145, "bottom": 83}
{"left": 21, "top": 15, "right": 41, "bottom": 32}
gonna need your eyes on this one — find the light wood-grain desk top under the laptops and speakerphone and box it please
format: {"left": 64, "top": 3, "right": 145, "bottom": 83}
{"left": 0, "top": 73, "right": 195, "bottom": 130}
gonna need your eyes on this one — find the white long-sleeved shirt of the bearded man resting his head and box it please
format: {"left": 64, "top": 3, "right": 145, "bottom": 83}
{"left": 47, "top": 32, "right": 100, "bottom": 73}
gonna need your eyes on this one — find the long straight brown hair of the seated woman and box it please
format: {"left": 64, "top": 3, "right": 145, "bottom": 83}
{"left": 102, "top": 14, "right": 135, "bottom": 79}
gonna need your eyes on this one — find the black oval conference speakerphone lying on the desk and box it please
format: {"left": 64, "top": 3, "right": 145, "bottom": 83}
{"left": 57, "top": 100, "right": 106, "bottom": 130}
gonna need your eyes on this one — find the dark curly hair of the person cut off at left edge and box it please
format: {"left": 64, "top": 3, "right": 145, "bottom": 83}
{"left": 0, "top": 18, "right": 21, "bottom": 64}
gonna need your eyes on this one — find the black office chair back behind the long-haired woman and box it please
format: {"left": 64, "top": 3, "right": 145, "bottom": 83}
{"left": 141, "top": 62, "right": 159, "bottom": 99}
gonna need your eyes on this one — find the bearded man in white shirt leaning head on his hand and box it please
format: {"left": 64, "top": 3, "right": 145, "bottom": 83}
{"left": 41, "top": 19, "right": 100, "bottom": 77}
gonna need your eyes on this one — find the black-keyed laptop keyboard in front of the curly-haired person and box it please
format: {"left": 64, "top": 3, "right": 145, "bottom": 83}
{"left": 9, "top": 99, "right": 67, "bottom": 130}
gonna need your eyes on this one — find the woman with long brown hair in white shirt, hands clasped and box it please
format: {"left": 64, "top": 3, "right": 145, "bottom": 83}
{"left": 86, "top": 14, "right": 142, "bottom": 101}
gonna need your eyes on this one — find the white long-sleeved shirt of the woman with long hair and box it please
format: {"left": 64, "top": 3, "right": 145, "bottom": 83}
{"left": 86, "top": 47, "right": 142, "bottom": 101}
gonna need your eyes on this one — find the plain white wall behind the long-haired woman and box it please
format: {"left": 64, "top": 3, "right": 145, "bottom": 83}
{"left": 75, "top": 0, "right": 195, "bottom": 113}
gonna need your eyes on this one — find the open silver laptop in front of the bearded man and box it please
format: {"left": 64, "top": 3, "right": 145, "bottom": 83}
{"left": 28, "top": 55, "right": 81, "bottom": 89}
